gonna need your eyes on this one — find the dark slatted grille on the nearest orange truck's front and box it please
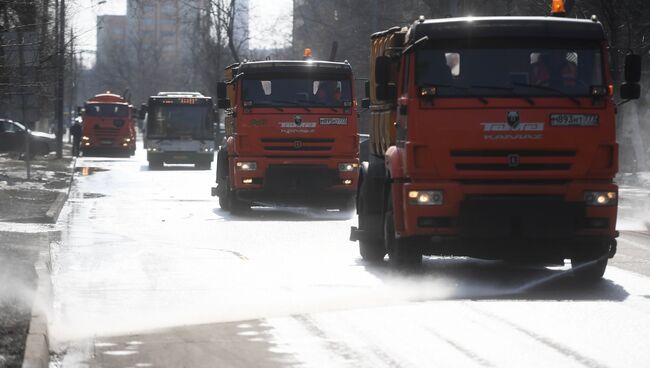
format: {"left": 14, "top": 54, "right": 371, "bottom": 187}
{"left": 450, "top": 150, "right": 576, "bottom": 171}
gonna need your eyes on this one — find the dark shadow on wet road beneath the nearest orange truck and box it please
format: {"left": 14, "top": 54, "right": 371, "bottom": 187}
{"left": 358, "top": 257, "right": 629, "bottom": 301}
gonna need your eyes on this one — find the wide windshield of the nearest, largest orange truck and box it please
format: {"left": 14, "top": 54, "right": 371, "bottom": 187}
{"left": 415, "top": 42, "right": 604, "bottom": 97}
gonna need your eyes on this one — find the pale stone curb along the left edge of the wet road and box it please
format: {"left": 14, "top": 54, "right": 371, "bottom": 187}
{"left": 22, "top": 158, "right": 77, "bottom": 368}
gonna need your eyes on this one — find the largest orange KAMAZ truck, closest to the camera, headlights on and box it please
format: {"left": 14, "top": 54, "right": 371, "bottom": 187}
{"left": 351, "top": 6, "right": 640, "bottom": 280}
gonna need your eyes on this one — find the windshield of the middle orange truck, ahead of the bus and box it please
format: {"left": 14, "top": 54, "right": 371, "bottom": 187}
{"left": 242, "top": 78, "right": 352, "bottom": 107}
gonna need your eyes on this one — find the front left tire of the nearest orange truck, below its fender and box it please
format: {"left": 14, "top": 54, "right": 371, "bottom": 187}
{"left": 384, "top": 192, "right": 422, "bottom": 269}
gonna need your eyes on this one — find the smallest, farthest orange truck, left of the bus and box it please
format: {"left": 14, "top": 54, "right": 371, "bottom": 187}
{"left": 80, "top": 92, "right": 136, "bottom": 157}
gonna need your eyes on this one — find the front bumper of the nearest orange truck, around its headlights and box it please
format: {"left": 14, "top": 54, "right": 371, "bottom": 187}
{"left": 397, "top": 182, "right": 618, "bottom": 241}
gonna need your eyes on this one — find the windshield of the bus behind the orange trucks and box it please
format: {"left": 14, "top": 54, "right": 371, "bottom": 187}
{"left": 146, "top": 105, "right": 213, "bottom": 139}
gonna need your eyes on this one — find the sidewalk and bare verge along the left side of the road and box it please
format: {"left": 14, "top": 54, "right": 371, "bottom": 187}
{"left": 0, "top": 145, "right": 74, "bottom": 368}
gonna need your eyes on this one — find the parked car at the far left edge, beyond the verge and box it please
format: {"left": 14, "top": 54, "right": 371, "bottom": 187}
{"left": 0, "top": 119, "right": 56, "bottom": 155}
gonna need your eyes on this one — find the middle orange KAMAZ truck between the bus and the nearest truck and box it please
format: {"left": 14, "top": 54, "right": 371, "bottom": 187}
{"left": 212, "top": 60, "right": 359, "bottom": 212}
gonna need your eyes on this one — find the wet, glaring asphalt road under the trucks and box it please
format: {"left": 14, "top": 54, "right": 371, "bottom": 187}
{"left": 50, "top": 150, "right": 650, "bottom": 368}
